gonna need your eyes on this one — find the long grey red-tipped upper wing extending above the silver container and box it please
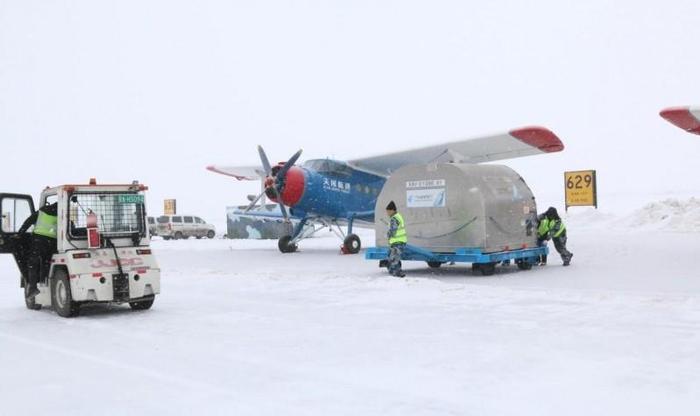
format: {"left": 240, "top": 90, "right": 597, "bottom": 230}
{"left": 348, "top": 126, "right": 564, "bottom": 176}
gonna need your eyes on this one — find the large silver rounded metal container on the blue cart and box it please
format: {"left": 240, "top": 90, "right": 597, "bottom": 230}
{"left": 375, "top": 163, "right": 537, "bottom": 253}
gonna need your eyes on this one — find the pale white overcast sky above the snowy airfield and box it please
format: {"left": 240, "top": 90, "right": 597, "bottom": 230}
{"left": 0, "top": 0, "right": 700, "bottom": 228}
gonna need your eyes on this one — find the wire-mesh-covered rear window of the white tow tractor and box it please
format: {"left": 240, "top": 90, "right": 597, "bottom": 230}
{"left": 68, "top": 192, "right": 145, "bottom": 238}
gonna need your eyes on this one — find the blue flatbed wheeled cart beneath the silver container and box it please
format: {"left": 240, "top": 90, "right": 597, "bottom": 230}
{"left": 365, "top": 244, "right": 549, "bottom": 276}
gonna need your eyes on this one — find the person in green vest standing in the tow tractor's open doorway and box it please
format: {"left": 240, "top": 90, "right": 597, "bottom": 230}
{"left": 18, "top": 202, "right": 58, "bottom": 298}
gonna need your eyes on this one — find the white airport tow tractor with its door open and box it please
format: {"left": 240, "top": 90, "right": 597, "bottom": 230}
{"left": 0, "top": 179, "right": 160, "bottom": 317}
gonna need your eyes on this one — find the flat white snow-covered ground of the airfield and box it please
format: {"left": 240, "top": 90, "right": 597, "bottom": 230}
{"left": 0, "top": 200, "right": 700, "bottom": 416}
